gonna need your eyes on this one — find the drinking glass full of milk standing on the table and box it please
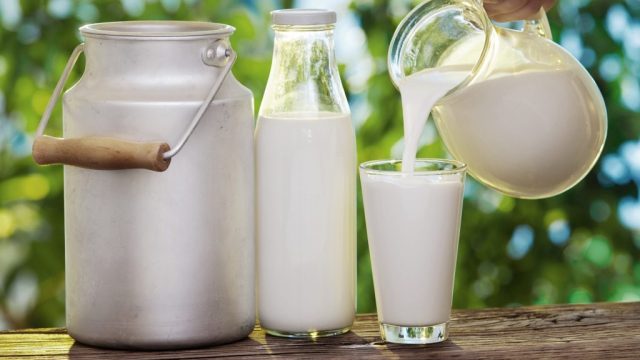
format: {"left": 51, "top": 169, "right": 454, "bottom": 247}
{"left": 360, "top": 159, "right": 467, "bottom": 344}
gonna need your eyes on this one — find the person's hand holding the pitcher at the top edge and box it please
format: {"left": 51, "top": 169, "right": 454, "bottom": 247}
{"left": 483, "top": 0, "right": 556, "bottom": 22}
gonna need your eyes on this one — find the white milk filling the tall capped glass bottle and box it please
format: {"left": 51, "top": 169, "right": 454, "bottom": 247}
{"left": 256, "top": 113, "right": 356, "bottom": 332}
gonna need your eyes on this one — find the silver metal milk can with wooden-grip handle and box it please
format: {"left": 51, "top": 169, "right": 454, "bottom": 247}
{"left": 33, "top": 21, "right": 255, "bottom": 349}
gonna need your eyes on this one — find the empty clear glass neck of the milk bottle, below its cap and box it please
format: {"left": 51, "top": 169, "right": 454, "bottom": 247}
{"left": 260, "top": 25, "right": 349, "bottom": 115}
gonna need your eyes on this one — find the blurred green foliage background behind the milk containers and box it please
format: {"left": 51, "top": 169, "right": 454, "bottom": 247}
{"left": 0, "top": 0, "right": 640, "bottom": 329}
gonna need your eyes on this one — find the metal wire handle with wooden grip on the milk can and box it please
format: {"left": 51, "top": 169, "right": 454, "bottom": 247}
{"left": 32, "top": 40, "right": 236, "bottom": 171}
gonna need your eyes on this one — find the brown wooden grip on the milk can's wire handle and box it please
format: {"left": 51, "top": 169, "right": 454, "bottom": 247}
{"left": 33, "top": 135, "right": 171, "bottom": 171}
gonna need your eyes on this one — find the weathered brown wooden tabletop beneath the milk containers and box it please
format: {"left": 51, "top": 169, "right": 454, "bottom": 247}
{"left": 0, "top": 302, "right": 640, "bottom": 360}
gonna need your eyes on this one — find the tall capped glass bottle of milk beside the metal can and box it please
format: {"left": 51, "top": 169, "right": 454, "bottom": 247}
{"left": 255, "top": 9, "right": 356, "bottom": 338}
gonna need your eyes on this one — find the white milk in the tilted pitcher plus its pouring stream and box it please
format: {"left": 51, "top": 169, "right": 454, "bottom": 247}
{"left": 399, "top": 67, "right": 606, "bottom": 198}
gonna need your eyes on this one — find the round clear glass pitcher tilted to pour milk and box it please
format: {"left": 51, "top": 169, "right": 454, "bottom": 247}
{"left": 388, "top": 0, "right": 607, "bottom": 199}
